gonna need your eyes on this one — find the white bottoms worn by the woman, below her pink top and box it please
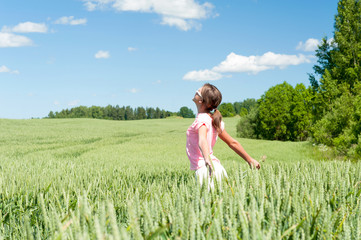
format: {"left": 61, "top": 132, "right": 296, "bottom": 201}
{"left": 195, "top": 161, "right": 228, "bottom": 190}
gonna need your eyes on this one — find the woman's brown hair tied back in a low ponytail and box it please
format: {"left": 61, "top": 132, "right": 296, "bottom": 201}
{"left": 201, "top": 83, "right": 222, "bottom": 133}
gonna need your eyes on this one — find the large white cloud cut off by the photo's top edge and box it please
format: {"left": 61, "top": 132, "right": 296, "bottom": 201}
{"left": 84, "top": 0, "right": 214, "bottom": 31}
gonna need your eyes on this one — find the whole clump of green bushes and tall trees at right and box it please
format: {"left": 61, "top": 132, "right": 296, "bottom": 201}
{"left": 237, "top": 0, "right": 361, "bottom": 158}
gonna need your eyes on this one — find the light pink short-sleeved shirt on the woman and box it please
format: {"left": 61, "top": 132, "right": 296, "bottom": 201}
{"left": 186, "top": 113, "right": 224, "bottom": 170}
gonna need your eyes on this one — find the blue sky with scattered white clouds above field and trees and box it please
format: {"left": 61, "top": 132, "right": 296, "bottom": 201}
{"left": 0, "top": 0, "right": 338, "bottom": 119}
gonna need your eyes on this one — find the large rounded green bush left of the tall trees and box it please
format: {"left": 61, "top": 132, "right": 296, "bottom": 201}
{"left": 256, "top": 82, "right": 312, "bottom": 141}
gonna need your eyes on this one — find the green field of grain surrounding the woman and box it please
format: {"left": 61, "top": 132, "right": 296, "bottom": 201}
{"left": 0, "top": 118, "right": 361, "bottom": 239}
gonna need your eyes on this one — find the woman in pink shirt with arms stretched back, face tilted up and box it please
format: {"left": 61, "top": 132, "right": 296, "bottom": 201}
{"left": 187, "top": 83, "right": 260, "bottom": 187}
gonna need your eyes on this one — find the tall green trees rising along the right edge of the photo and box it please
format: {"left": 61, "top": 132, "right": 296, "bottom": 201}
{"left": 310, "top": 0, "right": 361, "bottom": 157}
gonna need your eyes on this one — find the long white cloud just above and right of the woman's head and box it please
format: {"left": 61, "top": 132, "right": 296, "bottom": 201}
{"left": 183, "top": 52, "right": 311, "bottom": 81}
